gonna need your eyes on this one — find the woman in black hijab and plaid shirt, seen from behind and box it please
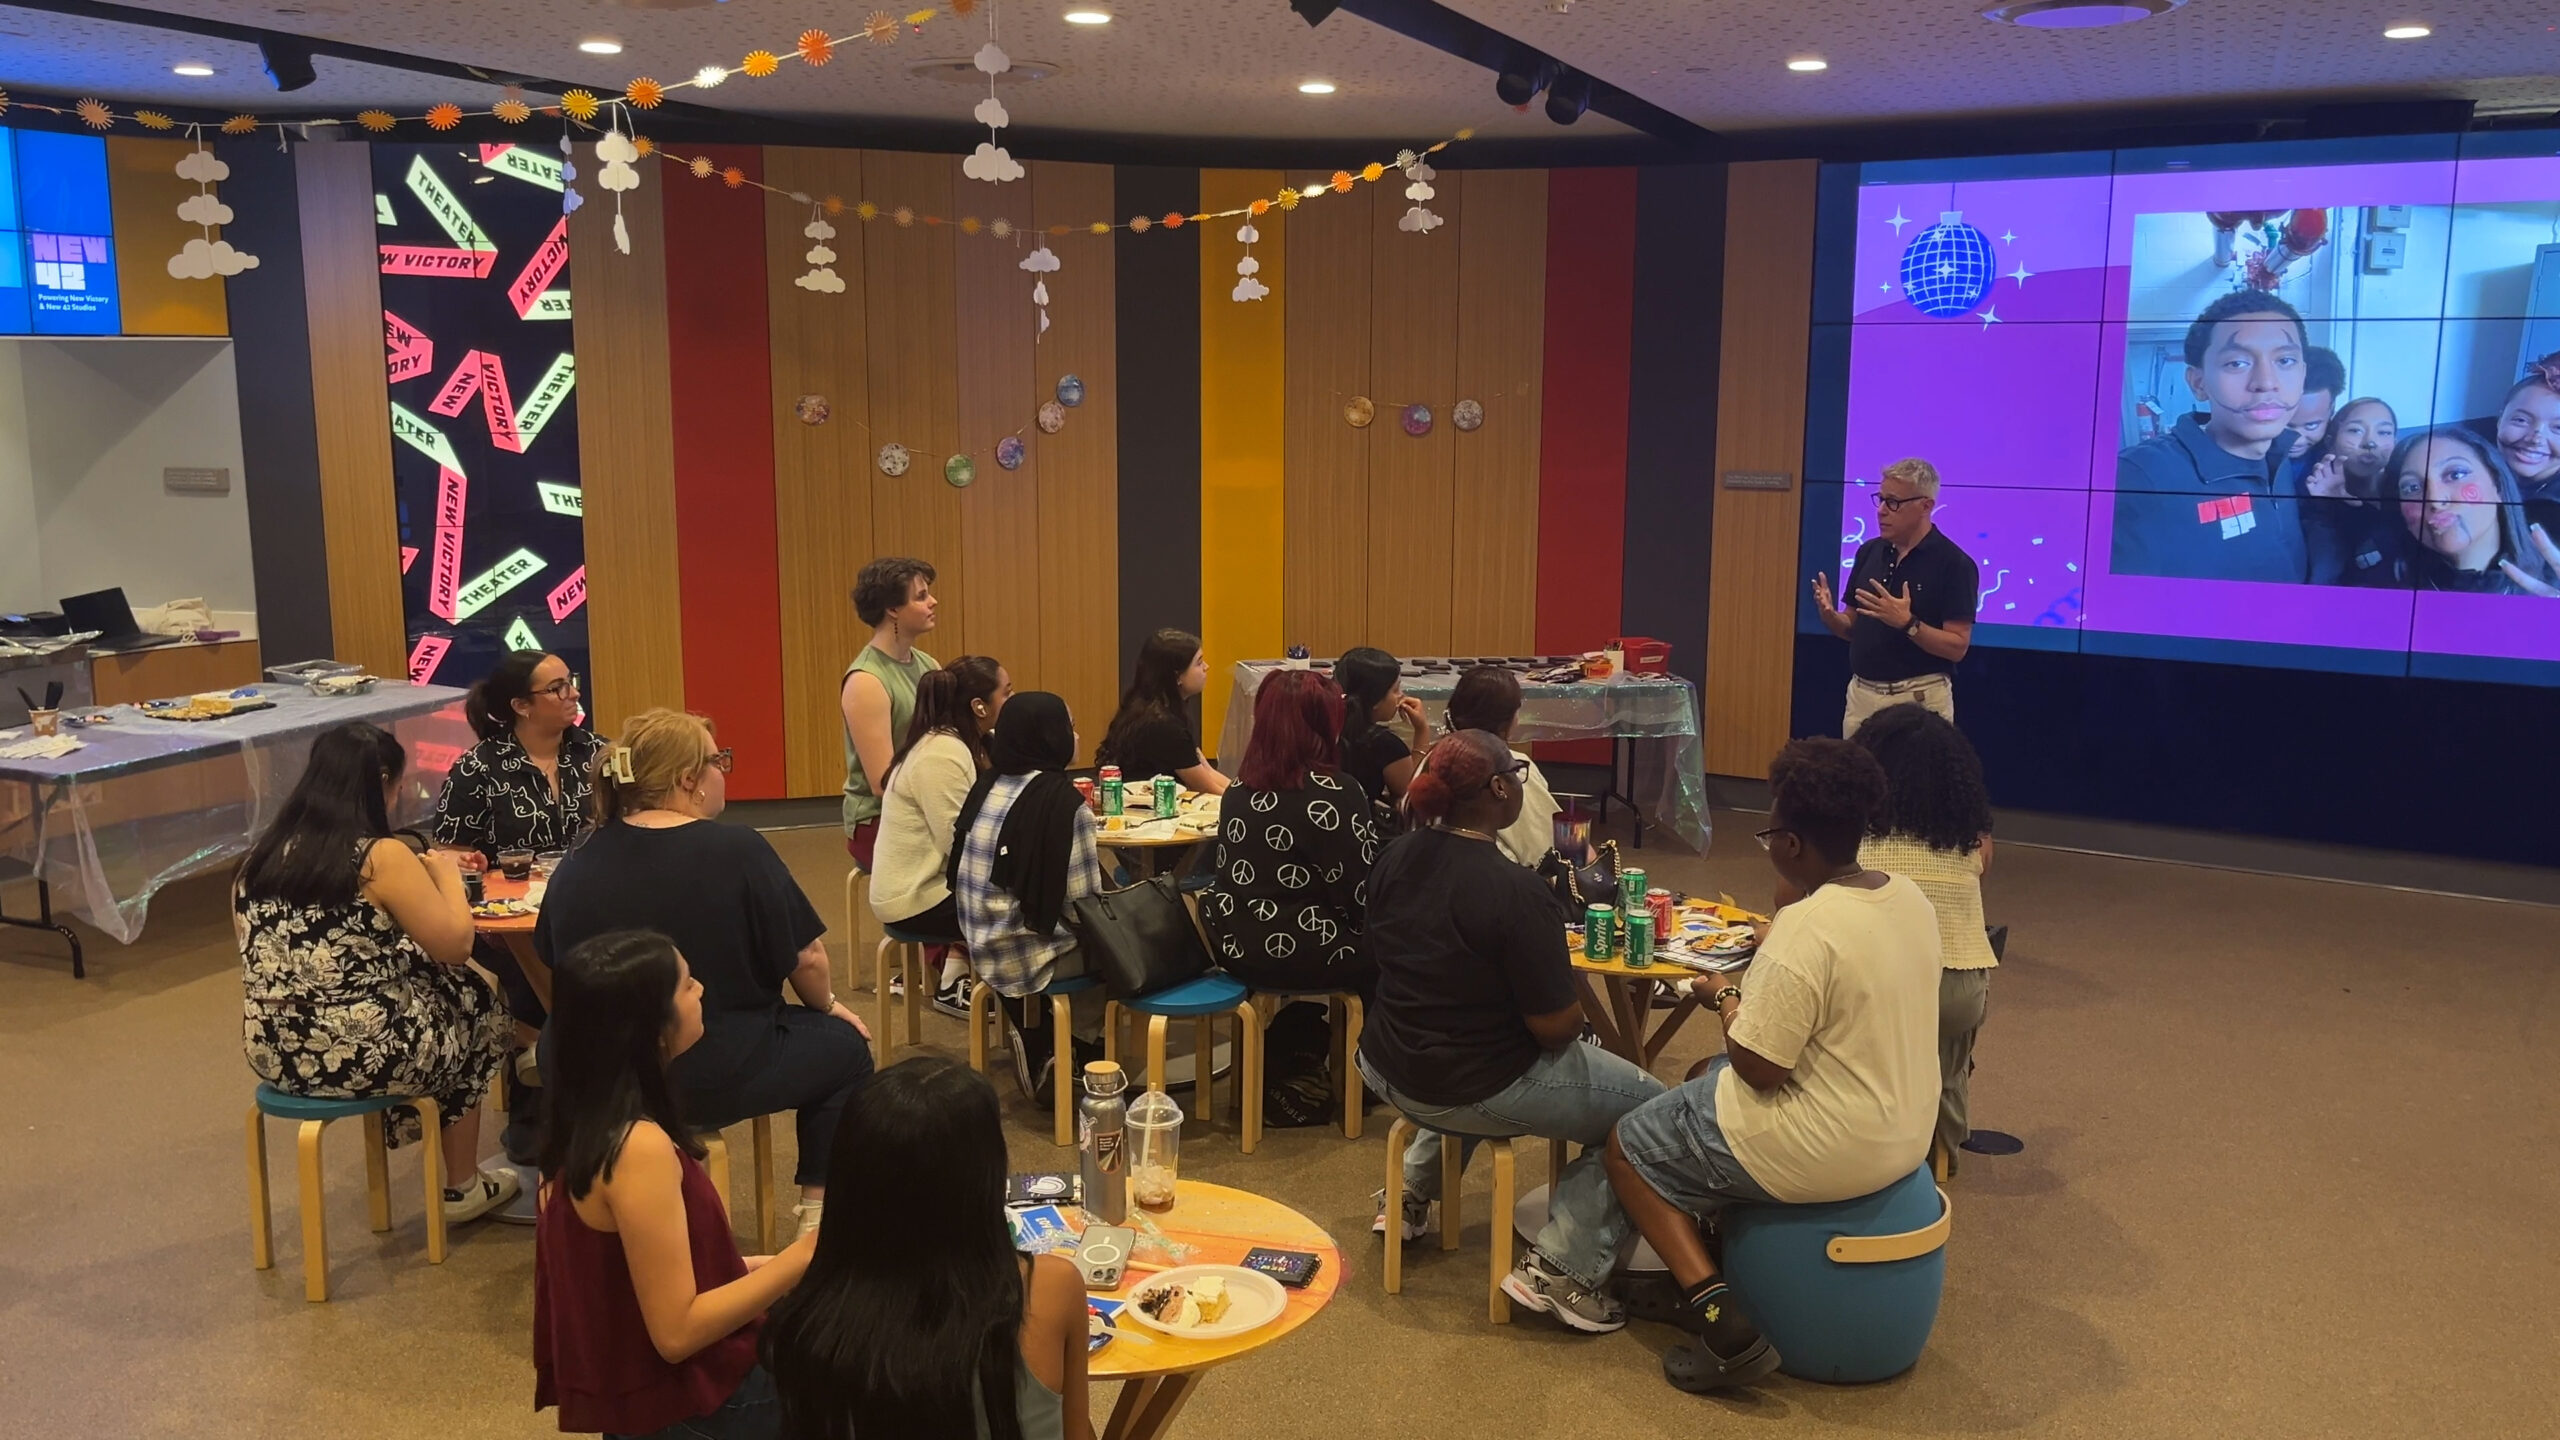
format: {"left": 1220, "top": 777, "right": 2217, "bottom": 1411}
{"left": 945, "top": 689, "right": 1103, "bottom": 1104}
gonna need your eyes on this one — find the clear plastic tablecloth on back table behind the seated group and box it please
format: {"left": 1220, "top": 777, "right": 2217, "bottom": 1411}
{"left": 1219, "top": 661, "right": 1713, "bottom": 853}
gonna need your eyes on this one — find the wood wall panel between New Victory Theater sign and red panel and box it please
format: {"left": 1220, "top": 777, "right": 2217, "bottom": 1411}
{"left": 570, "top": 143, "right": 694, "bottom": 730}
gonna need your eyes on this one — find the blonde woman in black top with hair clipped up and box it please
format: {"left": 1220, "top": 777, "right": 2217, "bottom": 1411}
{"left": 535, "top": 710, "right": 870, "bottom": 1230}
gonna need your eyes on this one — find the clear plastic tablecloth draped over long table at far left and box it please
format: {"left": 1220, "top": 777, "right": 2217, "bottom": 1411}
{"left": 0, "top": 682, "right": 471, "bottom": 945}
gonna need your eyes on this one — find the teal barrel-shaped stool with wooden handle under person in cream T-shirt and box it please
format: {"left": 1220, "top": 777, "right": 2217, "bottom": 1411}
{"left": 1723, "top": 1166, "right": 1956, "bottom": 1384}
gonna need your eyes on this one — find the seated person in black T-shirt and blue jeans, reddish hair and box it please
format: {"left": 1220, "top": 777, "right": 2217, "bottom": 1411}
{"left": 1359, "top": 730, "right": 1661, "bottom": 1332}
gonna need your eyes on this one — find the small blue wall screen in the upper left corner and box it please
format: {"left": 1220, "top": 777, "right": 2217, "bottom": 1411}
{"left": 0, "top": 128, "right": 123, "bottom": 336}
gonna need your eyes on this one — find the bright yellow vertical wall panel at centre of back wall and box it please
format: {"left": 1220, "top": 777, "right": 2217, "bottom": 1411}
{"left": 1201, "top": 169, "right": 1288, "bottom": 743}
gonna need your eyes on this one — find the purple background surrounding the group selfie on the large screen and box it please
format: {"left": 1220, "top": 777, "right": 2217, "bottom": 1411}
{"left": 1841, "top": 156, "right": 2560, "bottom": 661}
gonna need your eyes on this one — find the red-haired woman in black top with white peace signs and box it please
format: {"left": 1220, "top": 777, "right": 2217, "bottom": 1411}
{"left": 1201, "top": 671, "right": 1377, "bottom": 997}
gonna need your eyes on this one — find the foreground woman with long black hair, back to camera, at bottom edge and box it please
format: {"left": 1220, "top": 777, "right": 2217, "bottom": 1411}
{"left": 763, "top": 1056, "right": 1093, "bottom": 1440}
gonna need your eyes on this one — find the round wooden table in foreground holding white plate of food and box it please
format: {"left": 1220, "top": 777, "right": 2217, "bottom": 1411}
{"left": 1068, "top": 1181, "right": 1344, "bottom": 1440}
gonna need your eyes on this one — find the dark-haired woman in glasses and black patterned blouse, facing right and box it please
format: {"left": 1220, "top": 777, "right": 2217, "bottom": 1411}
{"left": 428, "top": 651, "right": 604, "bottom": 1024}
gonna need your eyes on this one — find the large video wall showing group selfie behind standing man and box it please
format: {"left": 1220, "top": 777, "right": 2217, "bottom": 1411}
{"left": 1802, "top": 131, "right": 2560, "bottom": 684}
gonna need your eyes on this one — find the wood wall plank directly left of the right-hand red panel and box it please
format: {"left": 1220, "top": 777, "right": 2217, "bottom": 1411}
{"left": 1431, "top": 169, "right": 1574, "bottom": 656}
